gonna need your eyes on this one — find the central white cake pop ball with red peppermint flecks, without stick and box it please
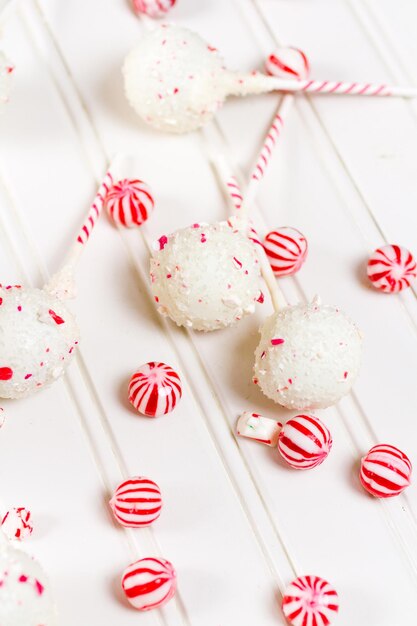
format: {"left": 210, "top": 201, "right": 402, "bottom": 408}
{"left": 151, "top": 222, "right": 263, "bottom": 331}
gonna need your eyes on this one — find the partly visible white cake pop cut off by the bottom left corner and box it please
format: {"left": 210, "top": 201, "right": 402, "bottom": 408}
{"left": 0, "top": 544, "right": 57, "bottom": 626}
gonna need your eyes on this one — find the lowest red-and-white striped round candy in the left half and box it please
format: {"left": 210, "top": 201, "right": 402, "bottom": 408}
{"left": 122, "top": 558, "right": 177, "bottom": 611}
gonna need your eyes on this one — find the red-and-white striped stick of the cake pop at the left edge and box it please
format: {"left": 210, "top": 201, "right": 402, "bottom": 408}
{"left": 45, "top": 157, "right": 120, "bottom": 299}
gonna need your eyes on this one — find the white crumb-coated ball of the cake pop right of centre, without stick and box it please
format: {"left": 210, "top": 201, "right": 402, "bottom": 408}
{"left": 254, "top": 302, "right": 362, "bottom": 410}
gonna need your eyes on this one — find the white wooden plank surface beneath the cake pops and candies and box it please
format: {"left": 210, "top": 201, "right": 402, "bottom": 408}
{"left": 0, "top": 0, "right": 417, "bottom": 626}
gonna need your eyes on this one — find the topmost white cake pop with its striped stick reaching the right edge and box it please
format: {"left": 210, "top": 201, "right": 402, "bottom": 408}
{"left": 123, "top": 24, "right": 417, "bottom": 133}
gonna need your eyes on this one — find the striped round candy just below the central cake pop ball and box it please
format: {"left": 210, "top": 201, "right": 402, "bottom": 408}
{"left": 129, "top": 361, "right": 182, "bottom": 417}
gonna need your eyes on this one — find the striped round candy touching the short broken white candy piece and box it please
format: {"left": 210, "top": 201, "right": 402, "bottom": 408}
{"left": 278, "top": 415, "right": 333, "bottom": 469}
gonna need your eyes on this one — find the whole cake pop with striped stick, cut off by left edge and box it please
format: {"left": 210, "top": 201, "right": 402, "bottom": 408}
{"left": 0, "top": 158, "right": 120, "bottom": 398}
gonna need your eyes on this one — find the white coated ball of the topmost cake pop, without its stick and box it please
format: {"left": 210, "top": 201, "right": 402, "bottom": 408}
{"left": 123, "top": 24, "right": 229, "bottom": 133}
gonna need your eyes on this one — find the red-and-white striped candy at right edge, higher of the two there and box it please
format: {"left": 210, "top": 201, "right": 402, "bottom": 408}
{"left": 368, "top": 245, "right": 417, "bottom": 293}
